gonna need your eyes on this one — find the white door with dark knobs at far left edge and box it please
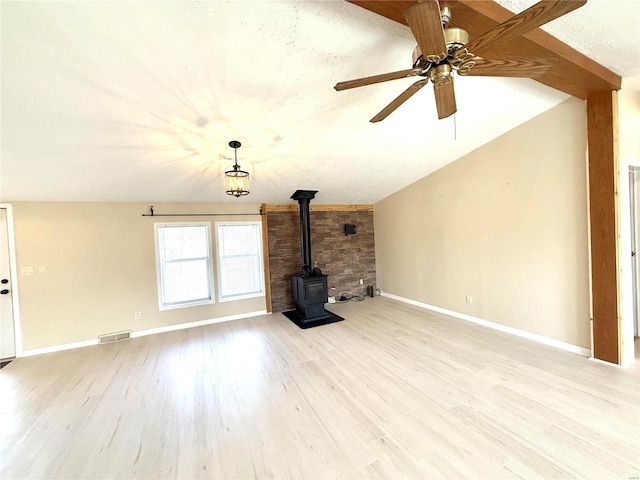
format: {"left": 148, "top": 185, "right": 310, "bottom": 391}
{"left": 0, "top": 208, "right": 16, "bottom": 360}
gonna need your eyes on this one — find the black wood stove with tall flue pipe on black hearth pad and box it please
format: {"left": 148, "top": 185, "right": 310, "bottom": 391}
{"left": 284, "top": 190, "right": 344, "bottom": 328}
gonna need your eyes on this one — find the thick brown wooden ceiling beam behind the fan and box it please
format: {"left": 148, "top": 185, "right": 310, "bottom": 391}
{"left": 347, "top": 0, "right": 622, "bottom": 100}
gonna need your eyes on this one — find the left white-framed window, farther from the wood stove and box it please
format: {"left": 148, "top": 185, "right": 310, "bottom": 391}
{"left": 154, "top": 223, "right": 213, "bottom": 310}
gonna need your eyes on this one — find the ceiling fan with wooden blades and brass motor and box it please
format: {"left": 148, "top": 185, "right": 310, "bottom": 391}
{"left": 334, "top": 0, "right": 587, "bottom": 122}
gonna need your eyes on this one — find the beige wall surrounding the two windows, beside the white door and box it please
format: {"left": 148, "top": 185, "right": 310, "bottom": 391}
{"left": 13, "top": 202, "right": 265, "bottom": 350}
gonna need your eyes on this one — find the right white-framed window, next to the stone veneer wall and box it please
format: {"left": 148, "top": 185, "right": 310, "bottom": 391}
{"left": 216, "top": 222, "right": 264, "bottom": 301}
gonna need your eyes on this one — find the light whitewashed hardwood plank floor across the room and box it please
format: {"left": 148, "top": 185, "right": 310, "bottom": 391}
{"left": 0, "top": 297, "right": 640, "bottom": 479}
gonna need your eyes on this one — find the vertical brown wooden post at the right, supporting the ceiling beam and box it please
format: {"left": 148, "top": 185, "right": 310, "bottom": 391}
{"left": 587, "top": 90, "right": 622, "bottom": 364}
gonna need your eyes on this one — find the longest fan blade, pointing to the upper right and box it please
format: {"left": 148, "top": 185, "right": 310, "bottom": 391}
{"left": 462, "top": 0, "right": 587, "bottom": 56}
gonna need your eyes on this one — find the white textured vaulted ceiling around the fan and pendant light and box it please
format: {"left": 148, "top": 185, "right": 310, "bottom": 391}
{"left": 0, "top": 0, "right": 640, "bottom": 203}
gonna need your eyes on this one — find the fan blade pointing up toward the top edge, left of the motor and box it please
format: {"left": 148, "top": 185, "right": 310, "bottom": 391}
{"left": 402, "top": 0, "right": 447, "bottom": 63}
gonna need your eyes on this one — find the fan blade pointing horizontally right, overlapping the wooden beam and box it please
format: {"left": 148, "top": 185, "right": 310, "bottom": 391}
{"left": 458, "top": 58, "right": 557, "bottom": 78}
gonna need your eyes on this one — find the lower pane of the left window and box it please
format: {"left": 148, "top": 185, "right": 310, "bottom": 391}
{"left": 164, "top": 260, "right": 209, "bottom": 304}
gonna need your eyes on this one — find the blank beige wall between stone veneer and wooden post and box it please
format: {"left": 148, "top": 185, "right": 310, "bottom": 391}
{"left": 374, "top": 99, "right": 590, "bottom": 348}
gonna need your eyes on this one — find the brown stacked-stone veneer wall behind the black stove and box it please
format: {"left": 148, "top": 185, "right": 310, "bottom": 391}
{"left": 267, "top": 210, "right": 376, "bottom": 312}
